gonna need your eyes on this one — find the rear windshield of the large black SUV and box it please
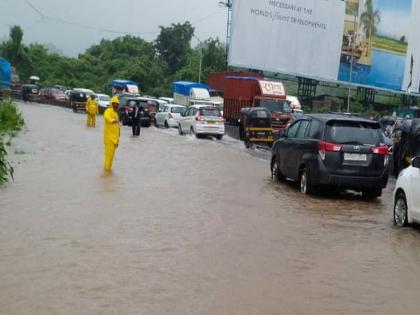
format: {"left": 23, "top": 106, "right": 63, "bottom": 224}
{"left": 324, "top": 121, "right": 384, "bottom": 145}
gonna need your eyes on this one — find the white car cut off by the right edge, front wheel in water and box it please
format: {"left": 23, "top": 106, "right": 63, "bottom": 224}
{"left": 394, "top": 156, "right": 420, "bottom": 226}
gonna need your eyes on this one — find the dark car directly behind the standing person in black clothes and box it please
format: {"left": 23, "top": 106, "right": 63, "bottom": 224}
{"left": 119, "top": 95, "right": 158, "bottom": 127}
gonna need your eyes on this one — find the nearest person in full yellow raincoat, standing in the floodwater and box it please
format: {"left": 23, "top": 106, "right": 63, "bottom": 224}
{"left": 104, "top": 96, "right": 120, "bottom": 171}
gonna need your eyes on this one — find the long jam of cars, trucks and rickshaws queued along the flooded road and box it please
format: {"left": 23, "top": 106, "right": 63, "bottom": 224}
{"left": 3, "top": 72, "right": 420, "bottom": 230}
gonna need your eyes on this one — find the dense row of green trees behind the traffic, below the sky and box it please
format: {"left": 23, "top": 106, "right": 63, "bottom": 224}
{"left": 0, "top": 22, "right": 226, "bottom": 96}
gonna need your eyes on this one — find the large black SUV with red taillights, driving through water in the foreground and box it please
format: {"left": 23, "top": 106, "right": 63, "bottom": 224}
{"left": 271, "top": 114, "right": 388, "bottom": 198}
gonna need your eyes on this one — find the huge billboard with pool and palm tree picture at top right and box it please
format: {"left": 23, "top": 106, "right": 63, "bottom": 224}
{"left": 229, "top": 0, "right": 420, "bottom": 92}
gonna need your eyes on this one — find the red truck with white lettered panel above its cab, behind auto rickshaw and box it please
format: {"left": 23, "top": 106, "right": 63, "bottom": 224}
{"left": 218, "top": 76, "right": 292, "bottom": 133}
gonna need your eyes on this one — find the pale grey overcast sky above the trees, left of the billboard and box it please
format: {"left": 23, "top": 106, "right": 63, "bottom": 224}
{"left": 0, "top": 0, "right": 227, "bottom": 56}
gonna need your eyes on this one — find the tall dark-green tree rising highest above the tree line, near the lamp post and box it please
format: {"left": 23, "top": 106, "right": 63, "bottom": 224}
{"left": 155, "top": 22, "right": 194, "bottom": 74}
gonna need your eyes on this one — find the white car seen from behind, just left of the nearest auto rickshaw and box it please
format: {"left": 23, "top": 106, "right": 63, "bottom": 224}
{"left": 178, "top": 105, "right": 225, "bottom": 140}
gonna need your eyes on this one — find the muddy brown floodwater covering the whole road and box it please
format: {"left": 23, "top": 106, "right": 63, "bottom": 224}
{"left": 0, "top": 104, "right": 420, "bottom": 315}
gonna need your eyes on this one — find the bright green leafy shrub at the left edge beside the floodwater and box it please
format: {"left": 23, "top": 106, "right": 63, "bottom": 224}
{"left": 0, "top": 99, "right": 24, "bottom": 185}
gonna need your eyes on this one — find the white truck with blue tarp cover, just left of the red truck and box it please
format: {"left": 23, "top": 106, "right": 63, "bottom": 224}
{"left": 172, "top": 81, "right": 217, "bottom": 106}
